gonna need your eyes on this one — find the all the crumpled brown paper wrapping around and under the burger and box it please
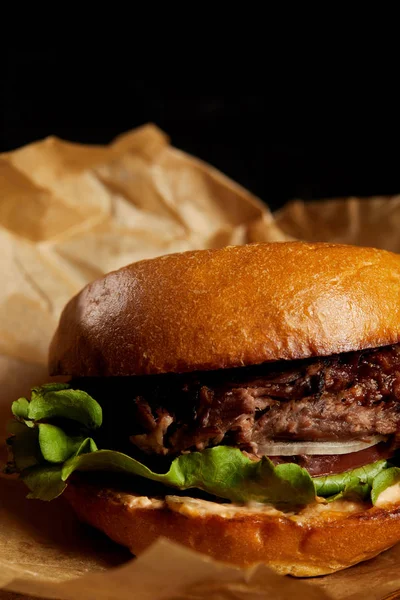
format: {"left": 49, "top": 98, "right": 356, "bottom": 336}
{"left": 0, "top": 125, "right": 400, "bottom": 600}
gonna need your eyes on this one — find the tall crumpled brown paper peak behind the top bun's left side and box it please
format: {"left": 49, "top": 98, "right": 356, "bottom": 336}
{"left": 0, "top": 125, "right": 285, "bottom": 364}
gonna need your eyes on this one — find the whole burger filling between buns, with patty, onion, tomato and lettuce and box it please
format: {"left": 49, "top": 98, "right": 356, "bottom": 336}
{"left": 9, "top": 345, "right": 400, "bottom": 507}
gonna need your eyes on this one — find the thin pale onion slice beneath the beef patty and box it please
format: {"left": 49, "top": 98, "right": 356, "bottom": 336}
{"left": 258, "top": 435, "right": 387, "bottom": 456}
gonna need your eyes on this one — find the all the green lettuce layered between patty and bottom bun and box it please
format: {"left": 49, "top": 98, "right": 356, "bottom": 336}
{"left": 4, "top": 384, "right": 400, "bottom": 509}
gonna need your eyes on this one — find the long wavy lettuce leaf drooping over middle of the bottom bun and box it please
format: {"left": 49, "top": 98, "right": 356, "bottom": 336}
{"left": 24, "top": 446, "right": 315, "bottom": 507}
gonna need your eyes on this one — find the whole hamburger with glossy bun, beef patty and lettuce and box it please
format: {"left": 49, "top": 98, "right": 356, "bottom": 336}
{"left": 8, "top": 242, "right": 400, "bottom": 577}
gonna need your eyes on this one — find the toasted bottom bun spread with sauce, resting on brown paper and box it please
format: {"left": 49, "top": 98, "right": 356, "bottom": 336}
{"left": 65, "top": 480, "right": 400, "bottom": 577}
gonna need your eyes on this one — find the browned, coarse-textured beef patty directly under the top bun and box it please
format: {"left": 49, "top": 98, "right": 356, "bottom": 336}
{"left": 72, "top": 344, "right": 400, "bottom": 462}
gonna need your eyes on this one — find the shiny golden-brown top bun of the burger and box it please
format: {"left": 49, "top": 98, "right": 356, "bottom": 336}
{"left": 49, "top": 242, "right": 400, "bottom": 376}
